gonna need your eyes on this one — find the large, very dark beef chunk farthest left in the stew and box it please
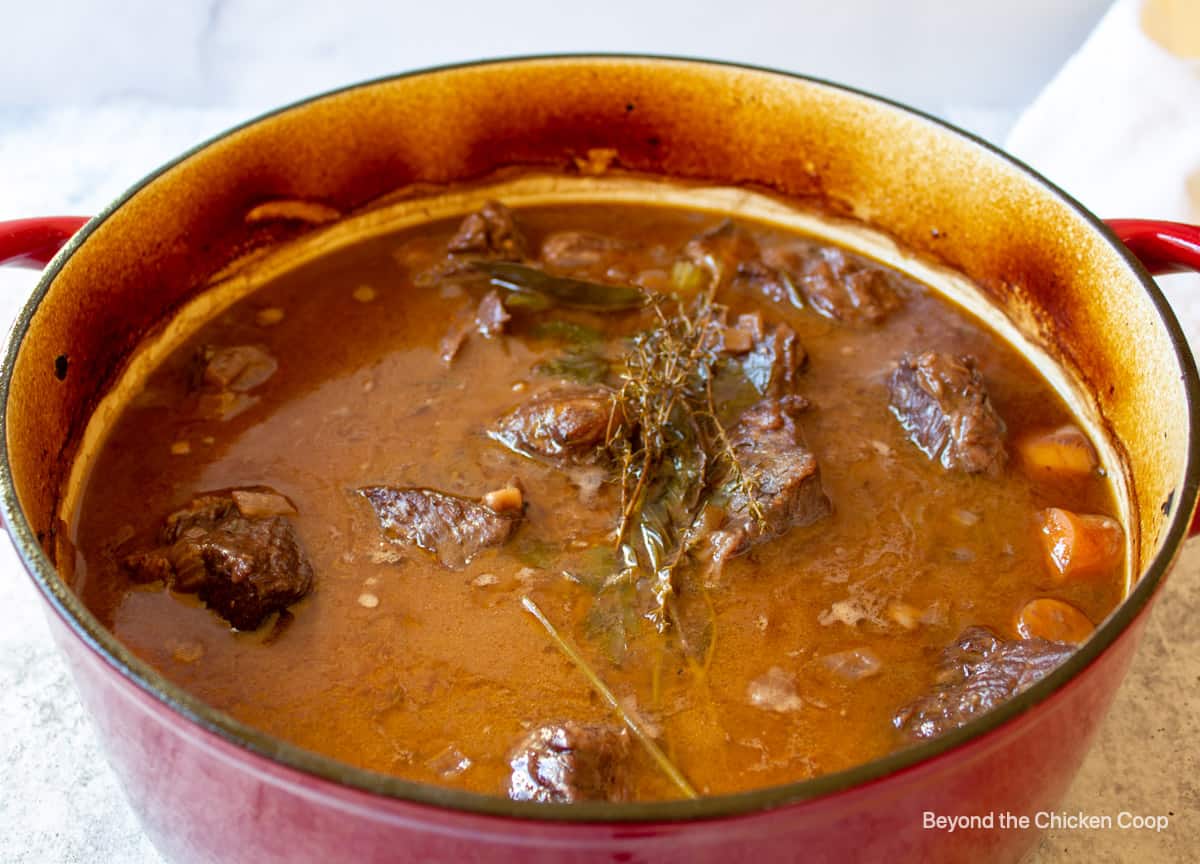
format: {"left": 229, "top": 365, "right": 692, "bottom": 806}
{"left": 124, "top": 488, "right": 312, "bottom": 630}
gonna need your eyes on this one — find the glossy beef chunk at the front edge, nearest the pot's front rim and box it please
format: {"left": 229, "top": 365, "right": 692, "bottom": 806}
{"left": 508, "top": 721, "right": 630, "bottom": 804}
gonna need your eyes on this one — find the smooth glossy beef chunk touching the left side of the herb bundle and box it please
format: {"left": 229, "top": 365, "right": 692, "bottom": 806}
{"left": 487, "top": 388, "right": 614, "bottom": 466}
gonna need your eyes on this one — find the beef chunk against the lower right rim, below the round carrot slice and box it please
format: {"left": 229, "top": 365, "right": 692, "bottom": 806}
{"left": 892, "top": 626, "right": 1074, "bottom": 739}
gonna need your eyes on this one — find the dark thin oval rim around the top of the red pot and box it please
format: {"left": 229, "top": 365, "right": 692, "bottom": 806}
{"left": 0, "top": 53, "right": 1200, "bottom": 823}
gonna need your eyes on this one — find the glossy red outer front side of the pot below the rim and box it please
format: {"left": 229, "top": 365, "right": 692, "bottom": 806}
{"left": 52, "top": 595, "right": 1148, "bottom": 864}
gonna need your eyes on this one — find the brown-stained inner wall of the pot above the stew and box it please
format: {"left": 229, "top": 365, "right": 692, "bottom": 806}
{"left": 6, "top": 58, "right": 1192, "bottom": 619}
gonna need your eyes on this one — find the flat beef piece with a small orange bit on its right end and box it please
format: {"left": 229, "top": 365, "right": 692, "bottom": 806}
{"left": 359, "top": 486, "right": 522, "bottom": 570}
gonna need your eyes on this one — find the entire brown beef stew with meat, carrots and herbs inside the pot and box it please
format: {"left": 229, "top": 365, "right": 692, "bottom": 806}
{"left": 74, "top": 203, "right": 1124, "bottom": 802}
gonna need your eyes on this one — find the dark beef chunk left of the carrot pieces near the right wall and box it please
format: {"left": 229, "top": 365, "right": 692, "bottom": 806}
{"left": 888, "top": 352, "right": 1008, "bottom": 474}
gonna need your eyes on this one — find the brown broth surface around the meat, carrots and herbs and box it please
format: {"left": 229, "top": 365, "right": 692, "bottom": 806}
{"left": 76, "top": 206, "right": 1123, "bottom": 798}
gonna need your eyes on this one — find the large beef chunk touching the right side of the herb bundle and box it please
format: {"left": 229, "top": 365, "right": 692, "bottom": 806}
{"left": 710, "top": 396, "right": 830, "bottom": 563}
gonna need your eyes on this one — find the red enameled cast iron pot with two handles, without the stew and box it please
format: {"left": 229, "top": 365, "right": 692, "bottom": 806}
{"left": 0, "top": 56, "right": 1200, "bottom": 864}
